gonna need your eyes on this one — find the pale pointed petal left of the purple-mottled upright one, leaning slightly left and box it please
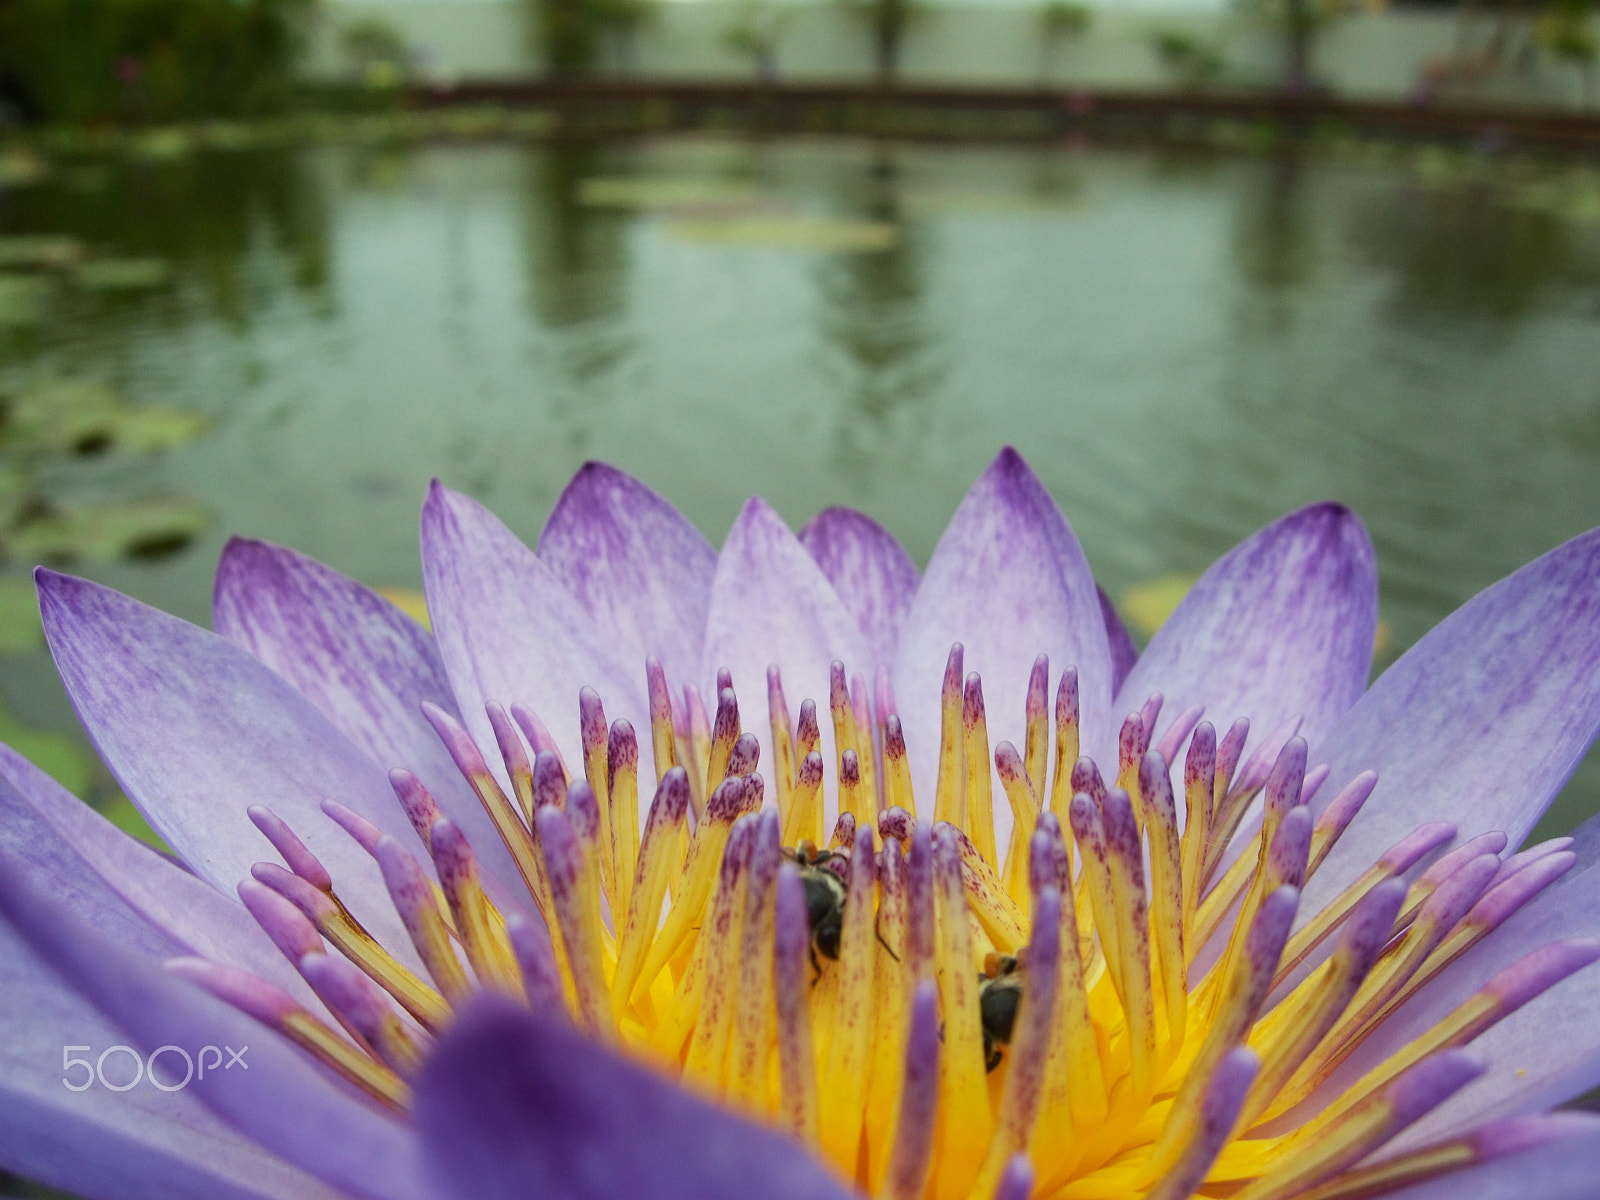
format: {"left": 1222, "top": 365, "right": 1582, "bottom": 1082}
{"left": 422, "top": 480, "right": 653, "bottom": 789}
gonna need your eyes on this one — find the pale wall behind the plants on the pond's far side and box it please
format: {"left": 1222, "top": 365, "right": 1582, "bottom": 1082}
{"left": 297, "top": 0, "right": 1579, "bottom": 104}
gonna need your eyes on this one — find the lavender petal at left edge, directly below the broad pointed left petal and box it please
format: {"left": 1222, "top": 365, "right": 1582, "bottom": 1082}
{"left": 0, "top": 746, "right": 310, "bottom": 1003}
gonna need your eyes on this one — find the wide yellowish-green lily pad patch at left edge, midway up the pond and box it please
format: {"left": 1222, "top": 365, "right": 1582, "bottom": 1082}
{"left": 0, "top": 379, "right": 206, "bottom": 454}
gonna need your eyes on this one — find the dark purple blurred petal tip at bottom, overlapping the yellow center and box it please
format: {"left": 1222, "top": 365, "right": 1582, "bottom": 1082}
{"left": 416, "top": 997, "right": 853, "bottom": 1200}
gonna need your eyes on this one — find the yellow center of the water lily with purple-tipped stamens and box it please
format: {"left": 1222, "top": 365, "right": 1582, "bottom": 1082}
{"left": 174, "top": 646, "right": 1594, "bottom": 1200}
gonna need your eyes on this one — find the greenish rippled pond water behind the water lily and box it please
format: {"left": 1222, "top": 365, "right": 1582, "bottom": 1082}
{"left": 0, "top": 131, "right": 1600, "bottom": 830}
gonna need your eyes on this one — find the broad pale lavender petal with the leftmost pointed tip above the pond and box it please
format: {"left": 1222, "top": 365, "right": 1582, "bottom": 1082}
{"left": 35, "top": 568, "right": 419, "bottom": 946}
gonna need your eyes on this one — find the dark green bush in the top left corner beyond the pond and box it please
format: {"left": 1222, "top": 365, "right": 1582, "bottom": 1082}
{"left": 0, "top": 0, "right": 314, "bottom": 122}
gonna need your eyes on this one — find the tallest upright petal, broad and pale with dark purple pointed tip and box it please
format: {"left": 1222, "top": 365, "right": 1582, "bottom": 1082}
{"left": 894, "top": 448, "right": 1115, "bottom": 800}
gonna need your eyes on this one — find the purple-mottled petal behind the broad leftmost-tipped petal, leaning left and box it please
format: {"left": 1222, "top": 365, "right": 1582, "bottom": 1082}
{"left": 211, "top": 538, "right": 517, "bottom": 894}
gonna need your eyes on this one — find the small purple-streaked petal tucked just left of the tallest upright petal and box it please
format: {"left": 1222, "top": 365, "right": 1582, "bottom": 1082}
{"left": 800, "top": 509, "right": 918, "bottom": 674}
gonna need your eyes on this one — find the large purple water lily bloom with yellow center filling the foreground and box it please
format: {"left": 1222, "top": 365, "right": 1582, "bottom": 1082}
{"left": 0, "top": 450, "right": 1600, "bottom": 1200}
